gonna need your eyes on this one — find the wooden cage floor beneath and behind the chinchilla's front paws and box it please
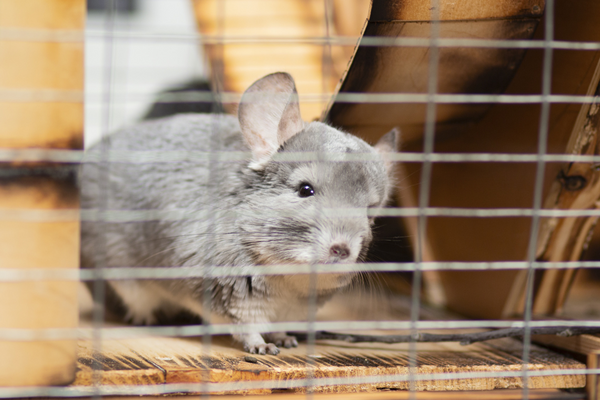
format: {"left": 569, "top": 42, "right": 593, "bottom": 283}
{"left": 73, "top": 290, "right": 585, "bottom": 398}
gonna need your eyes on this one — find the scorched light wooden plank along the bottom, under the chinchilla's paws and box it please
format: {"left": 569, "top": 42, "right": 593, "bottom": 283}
{"left": 74, "top": 332, "right": 585, "bottom": 393}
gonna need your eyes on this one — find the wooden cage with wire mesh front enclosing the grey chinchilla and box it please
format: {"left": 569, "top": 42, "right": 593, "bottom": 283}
{"left": 0, "top": 0, "right": 600, "bottom": 399}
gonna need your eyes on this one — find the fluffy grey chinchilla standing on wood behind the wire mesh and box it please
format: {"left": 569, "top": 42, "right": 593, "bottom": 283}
{"left": 80, "top": 73, "right": 399, "bottom": 354}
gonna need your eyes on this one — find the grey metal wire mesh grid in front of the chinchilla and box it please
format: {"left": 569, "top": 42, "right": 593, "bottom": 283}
{"left": 0, "top": 0, "right": 600, "bottom": 398}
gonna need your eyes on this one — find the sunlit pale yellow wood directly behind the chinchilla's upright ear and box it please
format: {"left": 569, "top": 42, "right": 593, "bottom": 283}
{"left": 194, "top": 0, "right": 347, "bottom": 121}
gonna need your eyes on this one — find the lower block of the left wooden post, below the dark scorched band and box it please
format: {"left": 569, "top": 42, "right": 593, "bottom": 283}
{"left": 0, "top": 177, "right": 79, "bottom": 386}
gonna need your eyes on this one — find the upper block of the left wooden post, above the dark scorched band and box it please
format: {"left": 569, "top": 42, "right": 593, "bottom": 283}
{"left": 0, "top": 0, "right": 85, "bottom": 149}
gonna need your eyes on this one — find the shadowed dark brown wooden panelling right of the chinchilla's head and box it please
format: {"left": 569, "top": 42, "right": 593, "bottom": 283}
{"left": 328, "top": 1, "right": 600, "bottom": 318}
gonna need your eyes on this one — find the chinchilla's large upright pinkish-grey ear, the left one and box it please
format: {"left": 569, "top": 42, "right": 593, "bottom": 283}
{"left": 238, "top": 72, "right": 304, "bottom": 170}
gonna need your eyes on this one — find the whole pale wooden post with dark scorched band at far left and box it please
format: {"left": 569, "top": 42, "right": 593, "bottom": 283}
{"left": 0, "top": 0, "right": 85, "bottom": 386}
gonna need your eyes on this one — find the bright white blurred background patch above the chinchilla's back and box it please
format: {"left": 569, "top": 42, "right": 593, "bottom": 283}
{"left": 85, "top": 0, "right": 207, "bottom": 147}
